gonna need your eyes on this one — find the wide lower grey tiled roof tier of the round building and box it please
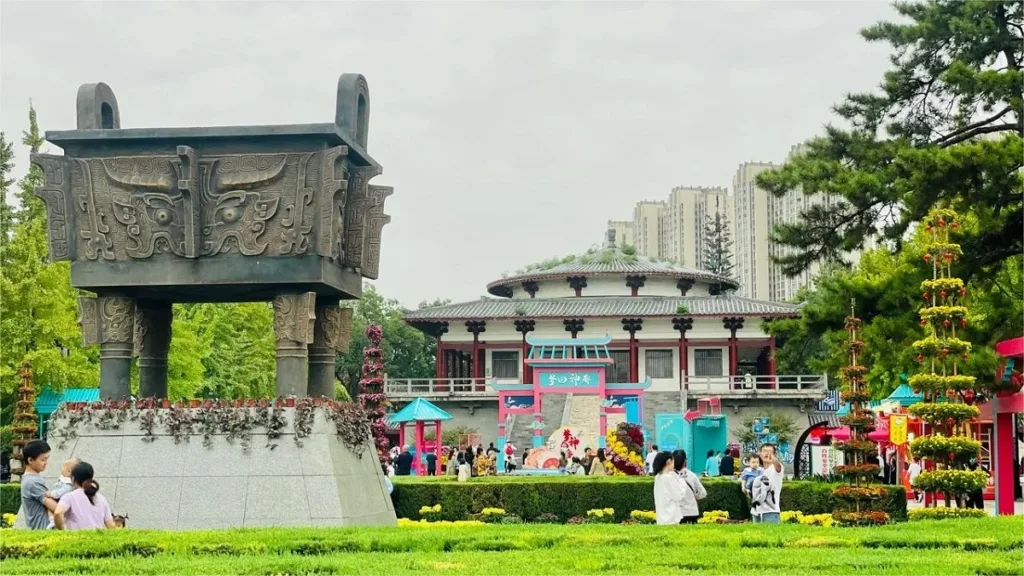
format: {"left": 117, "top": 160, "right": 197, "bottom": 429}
{"left": 404, "top": 294, "right": 800, "bottom": 324}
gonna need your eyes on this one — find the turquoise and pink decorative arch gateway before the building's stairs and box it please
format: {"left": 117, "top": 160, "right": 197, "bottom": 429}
{"left": 492, "top": 334, "right": 650, "bottom": 469}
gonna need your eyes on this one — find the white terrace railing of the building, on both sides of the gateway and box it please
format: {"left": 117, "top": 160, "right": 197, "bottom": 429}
{"left": 384, "top": 374, "right": 828, "bottom": 399}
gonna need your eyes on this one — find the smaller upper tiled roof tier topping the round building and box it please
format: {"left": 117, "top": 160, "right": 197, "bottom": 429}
{"left": 487, "top": 248, "right": 739, "bottom": 296}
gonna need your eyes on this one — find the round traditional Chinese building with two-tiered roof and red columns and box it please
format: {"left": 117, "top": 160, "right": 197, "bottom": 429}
{"left": 387, "top": 243, "right": 826, "bottom": 450}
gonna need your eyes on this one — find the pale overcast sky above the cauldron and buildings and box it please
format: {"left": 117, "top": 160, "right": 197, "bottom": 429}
{"left": 0, "top": 0, "right": 893, "bottom": 306}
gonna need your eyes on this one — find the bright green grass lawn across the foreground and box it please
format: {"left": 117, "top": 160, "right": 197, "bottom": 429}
{"left": 0, "top": 517, "right": 1024, "bottom": 576}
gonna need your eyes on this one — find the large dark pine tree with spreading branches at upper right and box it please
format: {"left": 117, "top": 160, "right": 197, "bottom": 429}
{"left": 758, "top": 0, "right": 1024, "bottom": 278}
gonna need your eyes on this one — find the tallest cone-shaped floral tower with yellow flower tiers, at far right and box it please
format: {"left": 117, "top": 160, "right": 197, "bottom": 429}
{"left": 909, "top": 209, "right": 988, "bottom": 502}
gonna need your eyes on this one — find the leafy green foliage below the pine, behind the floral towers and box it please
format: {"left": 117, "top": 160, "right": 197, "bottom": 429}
{"left": 767, "top": 216, "right": 1024, "bottom": 398}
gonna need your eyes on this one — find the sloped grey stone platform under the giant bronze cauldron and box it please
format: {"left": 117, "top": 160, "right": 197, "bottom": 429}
{"left": 18, "top": 409, "right": 396, "bottom": 530}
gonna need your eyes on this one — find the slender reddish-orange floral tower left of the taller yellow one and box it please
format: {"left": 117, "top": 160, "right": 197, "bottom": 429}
{"left": 833, "top": 305, "right": 889, "bottom": 525}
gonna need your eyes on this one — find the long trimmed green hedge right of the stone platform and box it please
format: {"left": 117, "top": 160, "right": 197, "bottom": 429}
{"left": 393, "top": 477, "right": 906, "bottom": 522}
